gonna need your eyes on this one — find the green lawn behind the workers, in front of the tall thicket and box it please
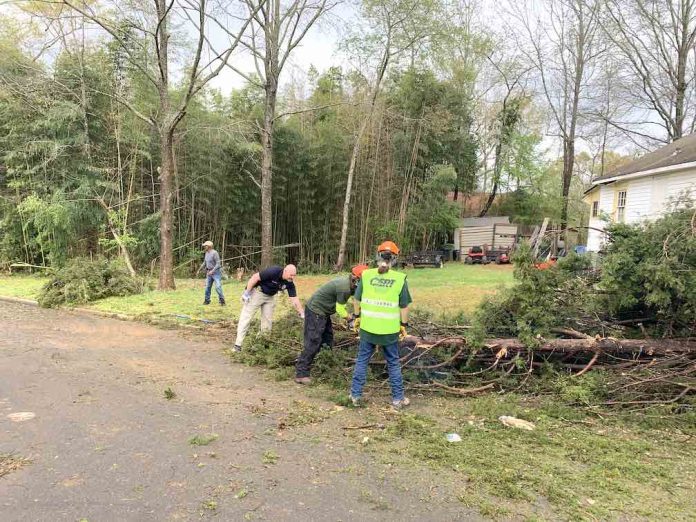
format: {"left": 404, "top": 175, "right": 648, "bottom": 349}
{"left": 0, "top": 263, "right": 512, "bottom": 322}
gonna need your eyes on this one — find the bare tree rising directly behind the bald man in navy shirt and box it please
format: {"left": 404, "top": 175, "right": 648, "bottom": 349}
{"left": 221, "top": 0, "right": 338, "bottom": 266}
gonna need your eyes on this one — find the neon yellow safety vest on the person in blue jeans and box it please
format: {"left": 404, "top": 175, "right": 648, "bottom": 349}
{"left": 360, "top": 268, "right": 406, "bottom": 335}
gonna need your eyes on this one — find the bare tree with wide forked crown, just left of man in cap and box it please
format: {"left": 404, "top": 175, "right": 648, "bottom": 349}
{"left": 42, "top": 0, "right": 256, "bottom": 290}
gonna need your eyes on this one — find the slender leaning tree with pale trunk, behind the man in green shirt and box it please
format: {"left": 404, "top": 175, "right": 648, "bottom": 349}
{"left": 335, "top": 0, "right": 439, "bottom": 270}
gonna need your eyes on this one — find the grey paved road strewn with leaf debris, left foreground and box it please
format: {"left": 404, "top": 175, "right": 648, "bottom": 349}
{"left": 0, "top": 301, "right": 470, "bottom": 522}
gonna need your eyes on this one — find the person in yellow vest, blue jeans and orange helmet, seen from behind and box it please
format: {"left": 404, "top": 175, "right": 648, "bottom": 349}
{"left": 350, "top": 241, "right": 411, "bottom": 409}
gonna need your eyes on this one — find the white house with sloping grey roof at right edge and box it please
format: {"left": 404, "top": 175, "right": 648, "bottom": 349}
{"left": 584, "top": 133, "right": 696, "bottom": 252}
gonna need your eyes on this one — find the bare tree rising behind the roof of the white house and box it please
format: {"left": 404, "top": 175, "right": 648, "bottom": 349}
{"left": 601, "top": 0, "right": 696, "bottom": 143}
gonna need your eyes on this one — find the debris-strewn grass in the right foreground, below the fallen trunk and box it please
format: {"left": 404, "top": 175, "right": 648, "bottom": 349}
{"left": 355, "top": 393, "right": 696, "bottom": 521}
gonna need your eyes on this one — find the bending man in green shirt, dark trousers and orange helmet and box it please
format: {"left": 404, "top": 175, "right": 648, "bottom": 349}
{"left": 295, "top": 265, "right": 367, "bottom": 384}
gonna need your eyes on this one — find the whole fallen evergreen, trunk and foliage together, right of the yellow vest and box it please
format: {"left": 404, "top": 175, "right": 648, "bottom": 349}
{"left": 386, "top": 209, "right": 696, "bottom": 407}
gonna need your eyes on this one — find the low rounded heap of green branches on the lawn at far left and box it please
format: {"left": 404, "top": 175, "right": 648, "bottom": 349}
{"left": 39, "top": 258, "right": 142, "bottom": 308}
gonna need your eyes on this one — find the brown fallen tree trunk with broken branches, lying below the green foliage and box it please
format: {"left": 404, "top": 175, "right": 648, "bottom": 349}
{"left": 386, "top": 329, "right": 696, "bottom": 406}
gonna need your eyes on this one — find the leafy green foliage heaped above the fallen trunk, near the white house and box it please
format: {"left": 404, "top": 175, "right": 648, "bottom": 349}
{"left": 471, "top": 208, "right": 696, "bottom": 340}
